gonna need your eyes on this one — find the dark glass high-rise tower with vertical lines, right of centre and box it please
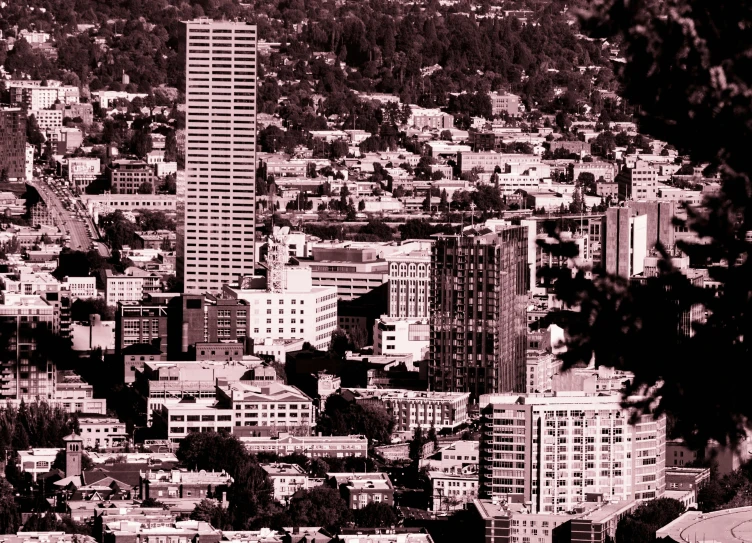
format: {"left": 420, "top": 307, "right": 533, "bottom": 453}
{"left": 428, "top": 225, "right": 529, "bottom": 398}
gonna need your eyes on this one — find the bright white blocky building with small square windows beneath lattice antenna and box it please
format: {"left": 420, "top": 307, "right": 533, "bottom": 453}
{"left": 223, "top": 264, "right": 337, "bottom": 350}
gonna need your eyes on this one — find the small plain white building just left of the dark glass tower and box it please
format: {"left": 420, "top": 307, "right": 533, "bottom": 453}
{"left": 373, "top": 315, "right": 431, "bottom": 360}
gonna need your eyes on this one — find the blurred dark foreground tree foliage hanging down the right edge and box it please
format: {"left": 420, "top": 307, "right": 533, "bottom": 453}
{"left": 543, "top": 0, "right": 752, "bottom": 446}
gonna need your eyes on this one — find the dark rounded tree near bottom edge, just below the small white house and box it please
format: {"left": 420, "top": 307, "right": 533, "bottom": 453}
{"left": 289, "top": 486, "right": 351, "bottom": 530}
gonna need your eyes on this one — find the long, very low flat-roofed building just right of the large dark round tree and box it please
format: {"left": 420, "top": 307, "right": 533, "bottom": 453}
{"left": 240, "top": 432, "right": 368, "bottom": 458}
